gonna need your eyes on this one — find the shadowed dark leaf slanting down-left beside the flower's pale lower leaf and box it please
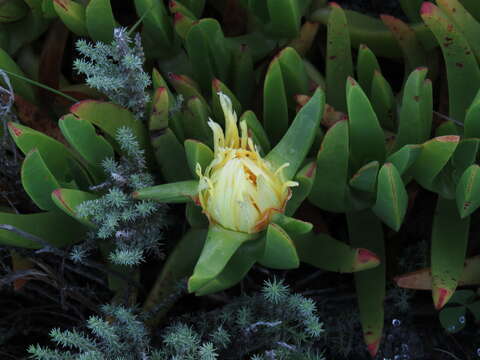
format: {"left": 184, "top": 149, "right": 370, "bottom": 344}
{"left": 143, "top": 229, "right": 207, "bottom": 328}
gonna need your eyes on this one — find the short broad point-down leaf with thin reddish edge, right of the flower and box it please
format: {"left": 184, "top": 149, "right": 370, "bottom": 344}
{"left": 372, "top": 163, "right": 408, "bottom": 231}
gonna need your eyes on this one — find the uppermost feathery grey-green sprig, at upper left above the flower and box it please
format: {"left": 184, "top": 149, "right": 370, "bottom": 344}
{"left": 73, "top": 28, "right": 151, "bottom": 119}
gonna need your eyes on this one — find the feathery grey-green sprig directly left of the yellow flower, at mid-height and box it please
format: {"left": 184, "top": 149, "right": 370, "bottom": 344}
{"left": 71, "top": 127, "right": 166, "bottom": 266}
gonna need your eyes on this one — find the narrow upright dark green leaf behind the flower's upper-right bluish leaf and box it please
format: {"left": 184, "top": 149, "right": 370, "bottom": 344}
{"left": 263, "top": 57, "right": 288, "bottom": 144}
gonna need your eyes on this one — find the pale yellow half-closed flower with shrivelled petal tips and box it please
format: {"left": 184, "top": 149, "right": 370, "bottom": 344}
{"left": 196, "top": 93, "right": 298, "bottom": 234}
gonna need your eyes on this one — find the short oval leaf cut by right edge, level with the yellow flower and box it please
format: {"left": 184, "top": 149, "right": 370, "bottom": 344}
{"left": 455, "top": 164, "right": 480, "bottom": 219}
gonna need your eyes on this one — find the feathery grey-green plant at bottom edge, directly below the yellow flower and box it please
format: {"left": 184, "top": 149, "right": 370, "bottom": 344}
{"left": 159, "top": 279, "right": 324, "bottom": 360}
